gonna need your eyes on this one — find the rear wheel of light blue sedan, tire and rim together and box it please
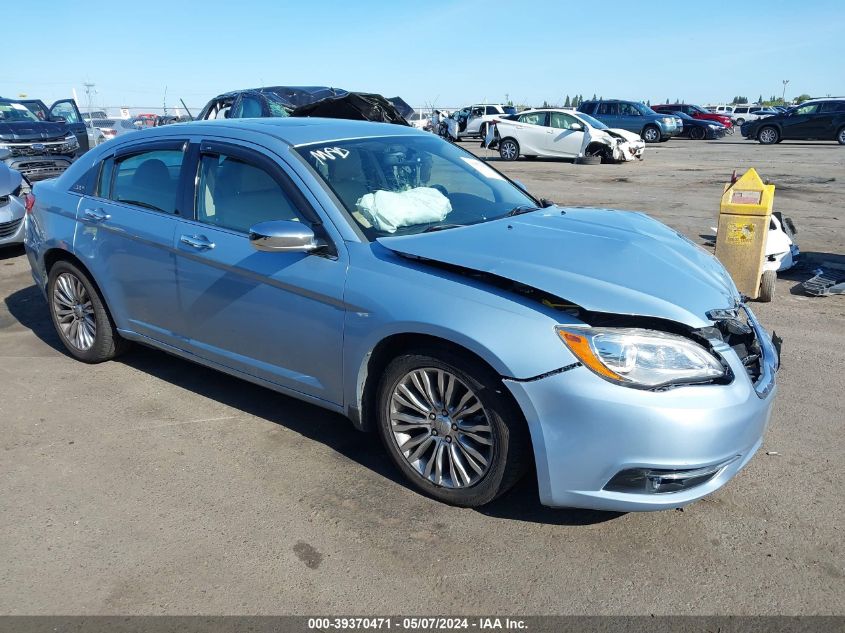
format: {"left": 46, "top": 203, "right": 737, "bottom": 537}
{"left": 47, "top": 261, "right": 128, "bottom": 363}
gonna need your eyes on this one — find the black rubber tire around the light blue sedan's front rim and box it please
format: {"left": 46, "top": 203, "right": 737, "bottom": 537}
{"left": 377, "top": 348, "right": 531, "bottom": 507}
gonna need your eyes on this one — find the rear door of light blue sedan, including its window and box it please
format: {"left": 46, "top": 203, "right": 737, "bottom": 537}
{"left": 74, "top": 139, "right": 188, "bottom": 346}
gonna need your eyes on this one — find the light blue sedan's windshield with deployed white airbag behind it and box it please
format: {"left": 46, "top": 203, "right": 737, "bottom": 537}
{"left": 295, "top": 134, "right": 538, "bottom": 241}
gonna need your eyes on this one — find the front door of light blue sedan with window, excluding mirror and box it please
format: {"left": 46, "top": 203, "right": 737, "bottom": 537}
{"left": 177, "top": 141, "right": 347, "bottom": 404}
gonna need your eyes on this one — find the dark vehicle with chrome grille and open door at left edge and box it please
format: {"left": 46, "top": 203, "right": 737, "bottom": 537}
{"left": 0, "top": 98, "right": 88, "bottom": 181}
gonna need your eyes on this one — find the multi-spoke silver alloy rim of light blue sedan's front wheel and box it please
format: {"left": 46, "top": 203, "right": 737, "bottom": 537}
{"left": 390, "top": 367, "right": 495, "bottom": 488}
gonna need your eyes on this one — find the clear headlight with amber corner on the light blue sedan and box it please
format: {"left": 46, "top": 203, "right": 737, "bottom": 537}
{"left": 556, "top": 327, "right": 725, "bottom": 389}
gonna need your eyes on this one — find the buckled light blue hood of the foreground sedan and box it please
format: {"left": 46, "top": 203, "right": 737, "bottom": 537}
{"left": 378, "top": 207, "right": 740, "bottom": 328}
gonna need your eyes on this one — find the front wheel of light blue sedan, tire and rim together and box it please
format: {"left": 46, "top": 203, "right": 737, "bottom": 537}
{"left": 378, "top": 350, "right": 530, "bottom": 507}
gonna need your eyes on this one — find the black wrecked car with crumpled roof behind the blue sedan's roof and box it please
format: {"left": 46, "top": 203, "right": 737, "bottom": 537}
{"left": 197, "top": 86, "right": 413, "bottom": 125}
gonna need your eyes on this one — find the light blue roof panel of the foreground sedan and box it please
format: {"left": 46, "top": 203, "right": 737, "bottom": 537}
{"left": 118, "top": 117, "right": 422, "bottom": 145}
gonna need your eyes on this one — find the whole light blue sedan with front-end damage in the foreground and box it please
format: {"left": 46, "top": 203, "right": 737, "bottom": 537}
{"left": 26, "top": 118, "right": 778, "bottom": 511}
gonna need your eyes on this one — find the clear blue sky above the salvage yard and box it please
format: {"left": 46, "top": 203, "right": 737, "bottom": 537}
{"left": 0, "top": 0, "right": 845, "bottom": 109}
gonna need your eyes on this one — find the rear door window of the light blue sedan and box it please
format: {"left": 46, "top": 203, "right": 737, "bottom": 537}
{"left": 108, "top": 149, "right": 184, "bottom": 213}
